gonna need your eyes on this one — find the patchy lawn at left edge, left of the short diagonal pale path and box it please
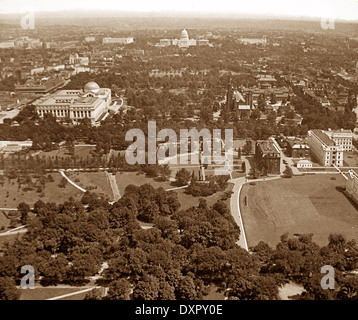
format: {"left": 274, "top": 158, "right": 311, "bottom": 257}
{"left": 0, "top": 172, "right": 82, "bottom": 208}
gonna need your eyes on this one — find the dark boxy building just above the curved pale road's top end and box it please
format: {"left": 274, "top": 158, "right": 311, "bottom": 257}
{"left": 255, "top": 140, "right": 281, "bottom": 174}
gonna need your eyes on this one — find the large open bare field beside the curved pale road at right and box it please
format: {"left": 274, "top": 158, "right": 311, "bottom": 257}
{"left": 240, "top": 174, "right": 358, "bottom": 247}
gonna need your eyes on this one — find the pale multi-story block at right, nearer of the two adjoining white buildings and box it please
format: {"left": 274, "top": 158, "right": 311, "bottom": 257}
{"left": 307, "top": 129, "right": 344, "bottom": 167}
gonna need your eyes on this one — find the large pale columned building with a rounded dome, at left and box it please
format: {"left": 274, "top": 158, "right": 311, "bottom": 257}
{"left": 34, "top": 82, "right": 111, "bottom": 123}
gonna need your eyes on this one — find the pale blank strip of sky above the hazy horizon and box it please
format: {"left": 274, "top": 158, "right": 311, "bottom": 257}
{"left": 0, "top": 0, "right": 358, "bottom": 21}
